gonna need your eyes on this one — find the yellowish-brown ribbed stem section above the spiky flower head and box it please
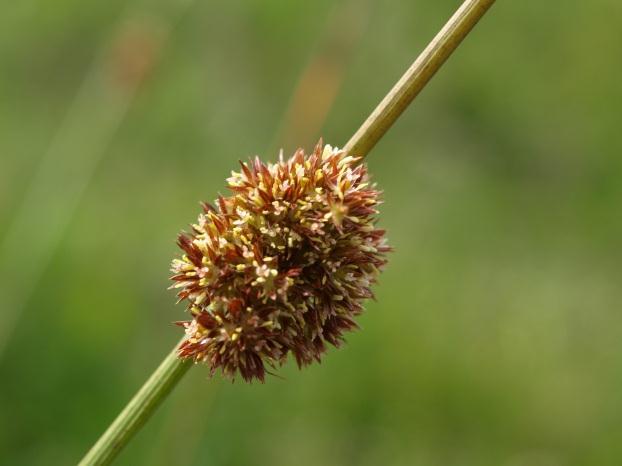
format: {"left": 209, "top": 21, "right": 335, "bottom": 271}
{"left": 344, "top": 0, "right": 495, "bottom": 157}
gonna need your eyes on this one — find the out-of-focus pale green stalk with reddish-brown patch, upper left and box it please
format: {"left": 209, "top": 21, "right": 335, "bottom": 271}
{"left": 0, "top": 2, "right": 190, "bottom": 358}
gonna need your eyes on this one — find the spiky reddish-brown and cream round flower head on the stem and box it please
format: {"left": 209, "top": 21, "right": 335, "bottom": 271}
{"left": 172, "top": 141, "right": 389, "bottom": 381}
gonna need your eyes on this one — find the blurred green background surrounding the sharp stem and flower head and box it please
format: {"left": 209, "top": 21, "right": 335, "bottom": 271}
{"left": 0, "top": 0, "right": 622, "bottom": 466}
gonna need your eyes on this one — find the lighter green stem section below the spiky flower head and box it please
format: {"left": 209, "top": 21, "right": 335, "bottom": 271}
{"left": 80, "top": 338, "right": 192, "bottom": 466}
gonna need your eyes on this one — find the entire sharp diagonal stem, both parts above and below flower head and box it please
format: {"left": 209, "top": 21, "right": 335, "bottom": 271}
{"left": 80, "top": 0, "right": 494, "bottom": 466}
